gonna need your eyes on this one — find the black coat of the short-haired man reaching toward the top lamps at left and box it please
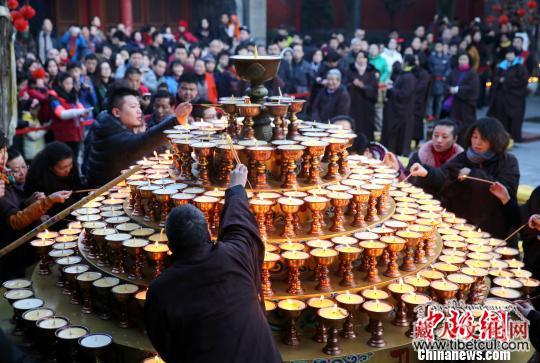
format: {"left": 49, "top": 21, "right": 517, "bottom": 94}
{"left": 85, "top": 112, "right": 176, "bottom": 187}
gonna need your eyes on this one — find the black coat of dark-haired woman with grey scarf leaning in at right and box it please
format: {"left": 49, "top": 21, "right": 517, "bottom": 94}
{"left": 426, "top": 151, "right": 519, "bottom": 238}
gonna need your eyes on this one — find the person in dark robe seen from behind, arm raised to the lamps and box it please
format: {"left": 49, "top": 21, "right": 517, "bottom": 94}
{"left": 145, "top": 165, "right": 281, "bottom": 363}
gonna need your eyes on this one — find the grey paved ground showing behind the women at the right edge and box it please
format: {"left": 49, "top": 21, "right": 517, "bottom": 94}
{"left": 478, "top": 96, "right": 540, "bottom": 187}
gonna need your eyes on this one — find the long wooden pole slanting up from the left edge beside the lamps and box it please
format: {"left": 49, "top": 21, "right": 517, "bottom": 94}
{"left": 0, "top": 165, "right": 142, "bottom": 258}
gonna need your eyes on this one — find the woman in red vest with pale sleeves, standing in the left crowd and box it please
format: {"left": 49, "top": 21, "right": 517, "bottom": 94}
{"left": 50, "top": 73, "right": 92, "bottom": 158}
